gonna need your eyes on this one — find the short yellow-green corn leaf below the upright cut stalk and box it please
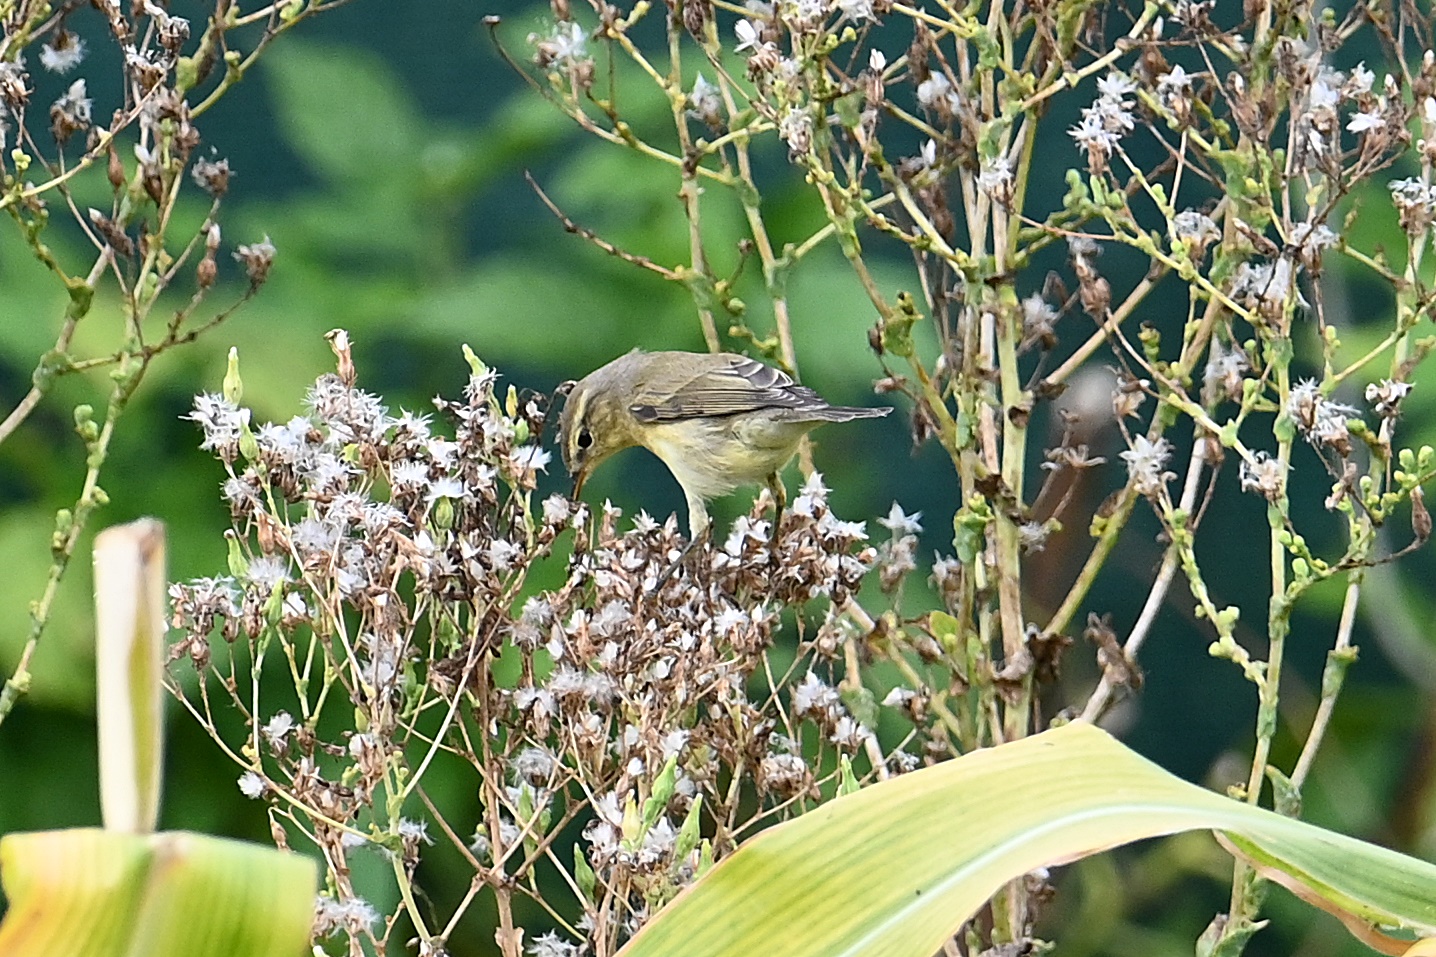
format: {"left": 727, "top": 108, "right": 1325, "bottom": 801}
{"left": 0, "top": 829, "right": 317, "bottom": 957}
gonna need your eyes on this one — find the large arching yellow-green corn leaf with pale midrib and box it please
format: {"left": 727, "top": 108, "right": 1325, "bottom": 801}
{"left": 622, "top": 723, "right": 1436, "bottom": 957}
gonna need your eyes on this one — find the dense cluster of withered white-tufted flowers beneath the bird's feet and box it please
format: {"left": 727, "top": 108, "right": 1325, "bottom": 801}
{"left": 171, "top": 333, "right": 915, "bottom": 954}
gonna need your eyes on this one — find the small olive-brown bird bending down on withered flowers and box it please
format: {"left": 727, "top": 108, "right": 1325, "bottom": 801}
{"left": 559, "top": 349, "right": 892, "bottom": 547}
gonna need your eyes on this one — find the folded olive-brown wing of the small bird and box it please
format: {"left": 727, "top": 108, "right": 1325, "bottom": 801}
{"left": 629, "top": 355, "right": 829, "bottom": 422}
